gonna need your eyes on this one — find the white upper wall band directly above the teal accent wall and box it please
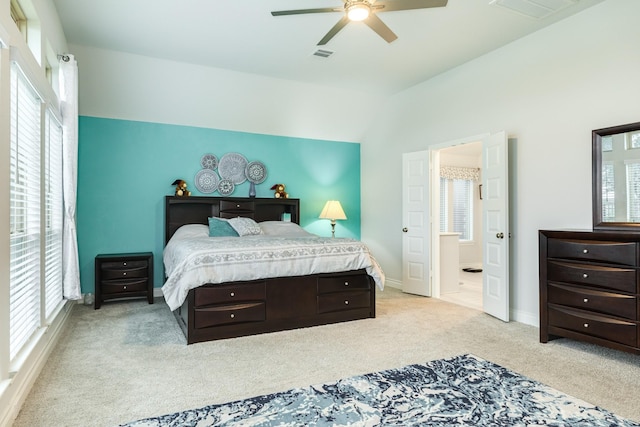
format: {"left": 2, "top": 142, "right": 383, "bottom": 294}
{"left": 70, "top": 45, "right": 382, "bottom": 142}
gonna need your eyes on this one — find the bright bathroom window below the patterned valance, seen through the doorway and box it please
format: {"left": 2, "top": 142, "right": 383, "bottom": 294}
{"left": 440, "top": 178, "right": 474, "bottom": 241}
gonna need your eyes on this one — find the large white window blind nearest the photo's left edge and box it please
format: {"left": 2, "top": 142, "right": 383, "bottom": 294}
{"left": 9, "top": 64, "right": 41, "bottom": 360}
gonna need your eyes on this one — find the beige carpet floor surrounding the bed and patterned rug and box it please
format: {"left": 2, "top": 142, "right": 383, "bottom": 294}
{"left": 10, "top": 288, "right": 640, "bottom": 427}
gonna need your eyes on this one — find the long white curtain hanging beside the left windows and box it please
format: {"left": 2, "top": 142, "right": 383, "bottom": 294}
{"left": 60, "top": 55, "right": 82, "bottom": 300}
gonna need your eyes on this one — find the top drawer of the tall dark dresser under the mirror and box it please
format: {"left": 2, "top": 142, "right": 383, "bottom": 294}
{"left": 547, "top": 239, "right": 638, "bottom": 266}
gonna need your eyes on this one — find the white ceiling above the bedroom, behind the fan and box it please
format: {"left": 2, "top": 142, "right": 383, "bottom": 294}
{"left": 53, "top": 0, "right": 603, "bottom": 95}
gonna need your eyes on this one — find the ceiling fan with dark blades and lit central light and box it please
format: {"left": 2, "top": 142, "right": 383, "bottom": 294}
{"left": 271, "top": 0, "right": 448, "bottom": 46}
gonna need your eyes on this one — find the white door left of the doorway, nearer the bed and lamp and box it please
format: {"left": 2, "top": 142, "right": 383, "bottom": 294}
{"left": 402, "top": 151, "right": 431, "bottom": 296}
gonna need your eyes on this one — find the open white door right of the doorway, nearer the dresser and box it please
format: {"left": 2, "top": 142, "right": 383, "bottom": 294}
{"left": 482, "top": 132, "right": 509, "bottom": 322}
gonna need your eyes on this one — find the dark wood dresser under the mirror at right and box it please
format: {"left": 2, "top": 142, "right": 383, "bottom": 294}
{"left": 539, "top": 230, "right": 640, "bottom": 354}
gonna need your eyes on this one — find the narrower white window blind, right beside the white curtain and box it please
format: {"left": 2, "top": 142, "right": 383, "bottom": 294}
{"left": 44, "top": 111, "right": 64, "bottom": 319}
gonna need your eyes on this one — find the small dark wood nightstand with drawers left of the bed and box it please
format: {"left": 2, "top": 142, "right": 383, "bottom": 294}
{"left": 94, "top": 252, "right": 153, "bottom": 310}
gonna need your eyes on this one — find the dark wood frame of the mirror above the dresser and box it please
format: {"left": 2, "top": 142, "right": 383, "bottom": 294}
{"left": 591, "top": 122, "right": 640, "bottom": 233}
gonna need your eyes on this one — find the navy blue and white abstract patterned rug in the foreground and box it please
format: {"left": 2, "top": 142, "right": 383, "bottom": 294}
{"left": 124, "top": 355, "right": 640, "bottom": 427}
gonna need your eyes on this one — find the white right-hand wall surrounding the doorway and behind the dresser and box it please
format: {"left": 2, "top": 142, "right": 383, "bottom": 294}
{"left": 361, "top": 0, "right": 640, "bottom": 324}
